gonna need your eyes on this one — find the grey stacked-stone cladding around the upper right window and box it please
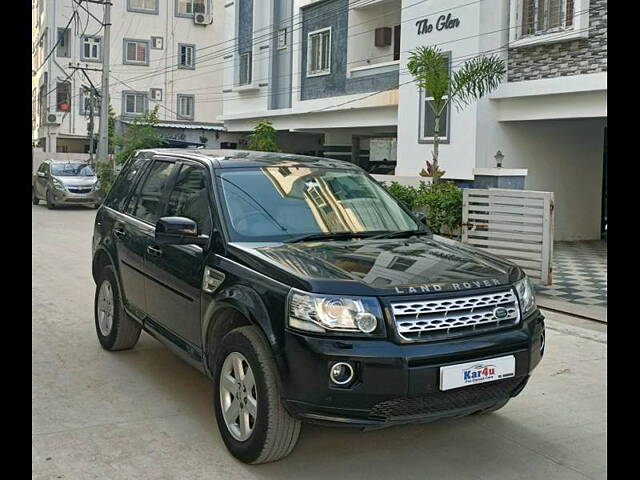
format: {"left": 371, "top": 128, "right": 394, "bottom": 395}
{"left": 507, "top": 0, "right": 607, "bottom": 82}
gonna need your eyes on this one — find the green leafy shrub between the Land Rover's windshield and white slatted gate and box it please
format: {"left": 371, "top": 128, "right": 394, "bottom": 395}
{"left": 385, "top": 182, "right": 462, "bottom": 235}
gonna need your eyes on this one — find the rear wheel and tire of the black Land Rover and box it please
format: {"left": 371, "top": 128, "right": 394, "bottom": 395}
{"left": 94, "top": 265, "right": 140, "bottom": 351}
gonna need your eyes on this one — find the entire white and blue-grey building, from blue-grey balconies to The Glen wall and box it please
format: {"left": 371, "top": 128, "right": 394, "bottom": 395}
{"left": 221, "top": 0, "right": 607, "bottom": 240}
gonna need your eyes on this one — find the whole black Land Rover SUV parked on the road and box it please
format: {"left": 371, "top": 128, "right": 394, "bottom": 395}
{"left": 93, "top": 149, "right": 544, "bottom": 463}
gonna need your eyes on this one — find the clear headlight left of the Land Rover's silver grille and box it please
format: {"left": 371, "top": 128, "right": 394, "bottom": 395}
{"left": 287, "top": 289, "right": 384, "bottom": 336}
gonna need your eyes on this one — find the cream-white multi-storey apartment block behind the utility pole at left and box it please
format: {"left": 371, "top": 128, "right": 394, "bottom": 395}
{"left": 32, "top": 0, "right": 236, "bottom": 152}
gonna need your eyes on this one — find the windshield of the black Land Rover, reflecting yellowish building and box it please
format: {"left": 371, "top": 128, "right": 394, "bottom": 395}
{"left": 219, "top": 166, "right": 424, "bottom": 242}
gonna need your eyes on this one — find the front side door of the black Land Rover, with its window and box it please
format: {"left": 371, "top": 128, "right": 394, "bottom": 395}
{"left": 145, "top": 161, "right": 212, "bottom": 351}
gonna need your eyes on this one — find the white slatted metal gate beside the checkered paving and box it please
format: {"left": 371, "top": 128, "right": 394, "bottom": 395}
{"left": 462, "top": 188, "right": 554, "bottom": 285}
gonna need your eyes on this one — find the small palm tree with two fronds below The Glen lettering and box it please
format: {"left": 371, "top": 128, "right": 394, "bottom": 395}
{"left": 407, "top": 46, "right": 506, "bottom": 183}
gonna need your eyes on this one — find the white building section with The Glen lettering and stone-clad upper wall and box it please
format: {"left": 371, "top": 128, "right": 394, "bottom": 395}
{"left": 396, "top": 0, "right": 607, "bottom": 240}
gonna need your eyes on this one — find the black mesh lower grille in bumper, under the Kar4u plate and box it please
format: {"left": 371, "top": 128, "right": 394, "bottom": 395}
{"left": 369, "top": 378, "right": 526, "bottom": 420}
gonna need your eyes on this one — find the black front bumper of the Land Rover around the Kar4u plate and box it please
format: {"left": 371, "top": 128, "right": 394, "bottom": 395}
{"left": 281, "top": 311, "right": 544, "bottom": 428}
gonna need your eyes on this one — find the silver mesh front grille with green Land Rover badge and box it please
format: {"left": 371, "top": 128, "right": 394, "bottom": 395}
{"left": 391, "top": 290, "right": 520, "bottom": 342}
